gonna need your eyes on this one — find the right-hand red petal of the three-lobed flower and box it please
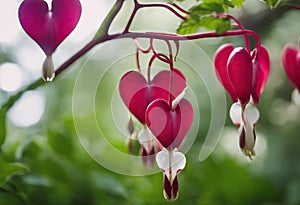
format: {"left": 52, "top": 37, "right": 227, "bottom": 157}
{"left": 252, "top": 47, "right": 270, "bottom": 104}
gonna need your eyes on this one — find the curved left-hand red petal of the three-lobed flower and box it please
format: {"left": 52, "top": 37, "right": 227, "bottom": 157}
{"left": 214, "top": 44, "right": 237, "bottom": 102}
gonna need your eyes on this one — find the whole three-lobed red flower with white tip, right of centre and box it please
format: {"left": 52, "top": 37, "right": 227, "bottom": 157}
{"left": 214, "top": 44, "right": 270, "bottom": 159}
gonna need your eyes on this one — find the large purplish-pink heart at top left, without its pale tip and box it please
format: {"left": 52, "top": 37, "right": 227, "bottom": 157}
{"left": 19, "top": 0, "right": 81, "bottom": 56}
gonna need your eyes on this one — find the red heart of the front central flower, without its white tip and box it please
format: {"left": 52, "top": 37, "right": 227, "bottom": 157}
{"left": 146, "top": 98, "right": 194, "bottom": 149}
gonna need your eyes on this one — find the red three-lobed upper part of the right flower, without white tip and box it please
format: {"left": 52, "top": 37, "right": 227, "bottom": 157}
{"left": 214, "top": 44, "right": 270, "bottom": 105}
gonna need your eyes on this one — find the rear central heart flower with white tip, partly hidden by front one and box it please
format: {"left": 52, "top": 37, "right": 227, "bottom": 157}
{"left": 119, "top": 69, "right": 186, "bottom": 167}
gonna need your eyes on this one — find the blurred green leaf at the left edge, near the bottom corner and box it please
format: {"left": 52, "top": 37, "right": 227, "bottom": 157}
{"left": 0, "top": 162, "right": 28, "bottom": 186}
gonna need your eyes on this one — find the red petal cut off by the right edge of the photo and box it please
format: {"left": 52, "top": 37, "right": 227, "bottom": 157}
{"left": 282, "top": 45, "right": 300, "bottom": 90}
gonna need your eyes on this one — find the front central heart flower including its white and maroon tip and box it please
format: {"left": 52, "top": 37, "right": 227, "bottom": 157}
{"left": 146, "top": 90, "right": 194, "bottom": 200}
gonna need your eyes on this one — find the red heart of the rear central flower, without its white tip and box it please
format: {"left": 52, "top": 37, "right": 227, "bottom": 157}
{"left": 119, "top": 69, "right": 186, "bottom": 124}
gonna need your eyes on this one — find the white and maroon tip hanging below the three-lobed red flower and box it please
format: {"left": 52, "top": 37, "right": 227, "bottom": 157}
{"left": 230, "top": 102, "right": 260, "bottom": 159}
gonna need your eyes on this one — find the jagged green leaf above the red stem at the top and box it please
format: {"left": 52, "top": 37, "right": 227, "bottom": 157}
{"left": 177, "top": 0, "right": 244, "bottom": 34}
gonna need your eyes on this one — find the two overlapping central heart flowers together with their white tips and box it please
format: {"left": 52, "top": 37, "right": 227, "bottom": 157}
{"left": 119, "top": 39, "right": 194, "bottom": 200}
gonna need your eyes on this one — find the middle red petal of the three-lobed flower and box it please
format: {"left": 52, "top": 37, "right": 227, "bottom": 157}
{"left": 227, "top": 47, "right": 253, "bottom": 104}
